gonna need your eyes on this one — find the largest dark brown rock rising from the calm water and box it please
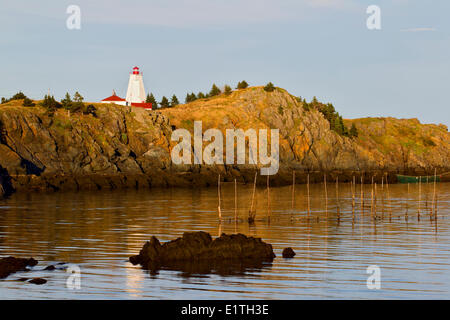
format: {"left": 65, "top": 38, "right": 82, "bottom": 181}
{"left": 130, "top": 232, "right": 275, "bottom": 273}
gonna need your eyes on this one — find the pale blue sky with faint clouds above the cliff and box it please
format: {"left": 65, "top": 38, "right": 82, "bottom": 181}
{"left": 0, "top": 0, "right": 450, "bottom": 126}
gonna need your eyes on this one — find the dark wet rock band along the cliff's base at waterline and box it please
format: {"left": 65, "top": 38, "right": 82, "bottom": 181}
{"left": 0, "top": 167, "right": 450, "bottom": 196}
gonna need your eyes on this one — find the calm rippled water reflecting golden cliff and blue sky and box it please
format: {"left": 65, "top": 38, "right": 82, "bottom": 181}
{"left": 0, "top": 183, "right": 450, "bottom": 299}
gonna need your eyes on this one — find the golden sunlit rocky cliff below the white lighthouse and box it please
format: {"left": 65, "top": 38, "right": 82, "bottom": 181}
{"left": 0, "top": 87, "right": 450, "bottom": 193}
